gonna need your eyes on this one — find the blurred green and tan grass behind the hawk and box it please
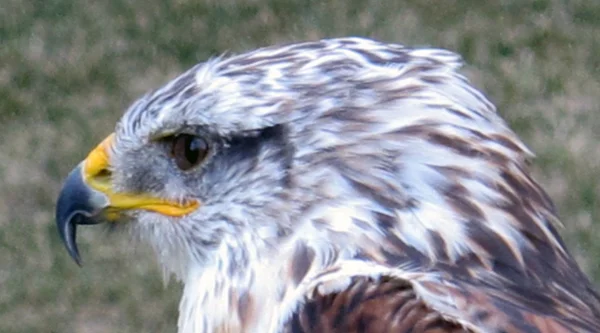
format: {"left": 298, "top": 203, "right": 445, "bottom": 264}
{"left": 0, "top": 0, "right": 600, "bottom": 333}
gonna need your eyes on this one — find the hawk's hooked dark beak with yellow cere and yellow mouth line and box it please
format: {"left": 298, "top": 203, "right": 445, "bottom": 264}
{"left": 56, "top": 134, "right": 200, "bottom": 265}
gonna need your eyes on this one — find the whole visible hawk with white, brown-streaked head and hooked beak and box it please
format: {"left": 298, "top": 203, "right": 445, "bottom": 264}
{"left": 56, "top": 38, "right": 600, "bottom": 333}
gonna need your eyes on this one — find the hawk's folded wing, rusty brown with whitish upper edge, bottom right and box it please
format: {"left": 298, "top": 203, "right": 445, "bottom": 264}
{"left": 282, "top": 263, "right": 600, "bottom": 333}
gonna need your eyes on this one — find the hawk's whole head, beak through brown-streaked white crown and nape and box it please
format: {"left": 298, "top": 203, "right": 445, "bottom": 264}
{"left": 57, "top": 39, "right": 544, "bottom": 288}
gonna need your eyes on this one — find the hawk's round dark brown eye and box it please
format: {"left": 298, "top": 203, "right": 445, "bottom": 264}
{"left": 171, "top": 134, "right": 208, "bottom": 170}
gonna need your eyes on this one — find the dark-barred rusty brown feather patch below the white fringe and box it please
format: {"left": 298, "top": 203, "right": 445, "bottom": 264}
{"left": 284, "top": 277, "right": 470, "bottom": 333}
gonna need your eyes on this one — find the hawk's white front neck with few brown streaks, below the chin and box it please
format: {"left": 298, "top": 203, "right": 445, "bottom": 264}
{"left": 173, "top": 220, "right": 368, "bottom": 333}
